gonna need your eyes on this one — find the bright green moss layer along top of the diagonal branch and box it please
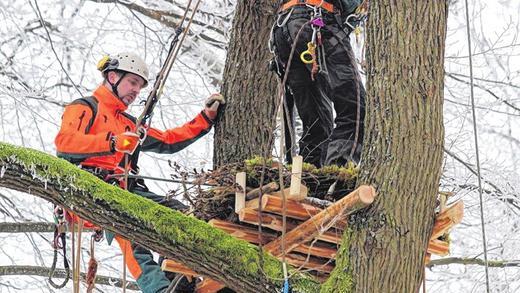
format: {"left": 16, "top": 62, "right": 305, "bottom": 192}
{"left": 0, "top": 143, "right": 319, "bottom": 292}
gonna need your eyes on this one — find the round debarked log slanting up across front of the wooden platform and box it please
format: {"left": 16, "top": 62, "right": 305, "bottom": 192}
{"left": 264, "top": 185, "right": 376, "bottom": 256}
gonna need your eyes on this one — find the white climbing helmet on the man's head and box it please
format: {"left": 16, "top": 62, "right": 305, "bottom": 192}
{"left": 97, "top": 52, "right": 148, "bottom": 87}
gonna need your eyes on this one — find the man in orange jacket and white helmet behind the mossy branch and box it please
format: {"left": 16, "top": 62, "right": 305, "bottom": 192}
{"left": 55, "top": 53, "right": 225, "bottom": 293}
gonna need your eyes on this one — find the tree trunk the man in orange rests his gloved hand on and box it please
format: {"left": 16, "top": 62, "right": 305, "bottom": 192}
{"left": 213, "top": 0, "right": 278, "bottom": 166}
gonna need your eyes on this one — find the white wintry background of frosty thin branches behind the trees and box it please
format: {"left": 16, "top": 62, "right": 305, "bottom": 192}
{"left": 0, "top": 0, "right": 520, "bottom": 292}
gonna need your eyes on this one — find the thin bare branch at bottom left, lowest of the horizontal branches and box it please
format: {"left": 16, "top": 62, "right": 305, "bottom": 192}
{"left": 0, "top": 266, "right": 139, "bottom": 291}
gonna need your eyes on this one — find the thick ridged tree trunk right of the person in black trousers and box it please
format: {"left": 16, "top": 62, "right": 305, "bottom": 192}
{"left": 322, "top": 0, "right": 448, "bottom": 292}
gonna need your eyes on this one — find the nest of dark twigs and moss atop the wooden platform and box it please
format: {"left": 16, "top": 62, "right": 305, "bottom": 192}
{"left": 170, "top": 158, "right": 359, "bottom": 222}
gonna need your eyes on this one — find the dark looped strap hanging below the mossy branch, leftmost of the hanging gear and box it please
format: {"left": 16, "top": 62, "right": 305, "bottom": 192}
{"left": 48, "top": 206, "right": 70, "bottom": 289}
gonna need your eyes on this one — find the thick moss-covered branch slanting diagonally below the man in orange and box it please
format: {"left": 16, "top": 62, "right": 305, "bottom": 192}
{"left": 0, "top": 143, "right": 318, "bottom": 292}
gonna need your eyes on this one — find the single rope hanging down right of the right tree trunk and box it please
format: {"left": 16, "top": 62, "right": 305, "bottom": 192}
{"left": 464, "top": 0, "right": 490, "bottom": 293}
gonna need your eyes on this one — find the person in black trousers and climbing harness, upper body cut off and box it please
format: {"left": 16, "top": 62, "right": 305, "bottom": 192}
{"left": 270, "top": 0, "right": 365, "bottom": 167}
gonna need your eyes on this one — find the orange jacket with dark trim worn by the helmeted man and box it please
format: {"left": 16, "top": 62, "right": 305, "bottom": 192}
{"left": 54, "top": 85, "right": 212, "bottom": 171}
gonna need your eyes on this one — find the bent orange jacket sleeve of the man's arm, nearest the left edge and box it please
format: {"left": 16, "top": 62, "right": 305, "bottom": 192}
{"left": 54, "top": 104, "right": 112, "bottom": 162}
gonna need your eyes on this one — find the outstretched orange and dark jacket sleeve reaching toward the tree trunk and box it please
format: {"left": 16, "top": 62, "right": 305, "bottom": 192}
{"left": 142, "top": 111, "right": 213, "bottom": 154}
